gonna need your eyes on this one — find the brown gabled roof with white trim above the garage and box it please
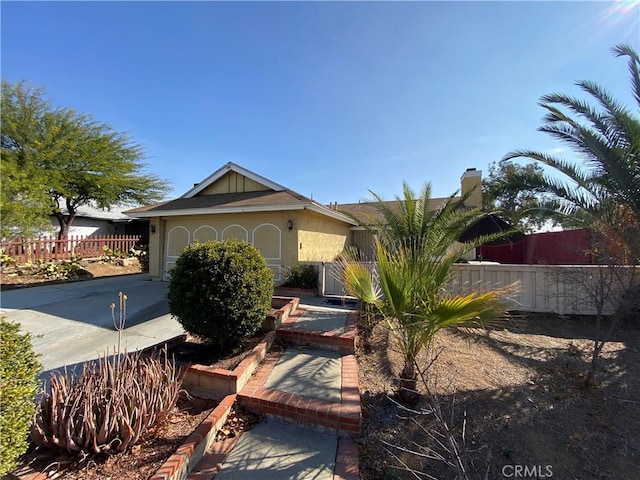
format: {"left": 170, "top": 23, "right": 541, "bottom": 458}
{"left": 125, "top": 163, "right": 356, "bottom": 225}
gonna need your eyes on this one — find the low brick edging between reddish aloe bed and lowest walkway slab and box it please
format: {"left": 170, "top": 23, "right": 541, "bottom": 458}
{"left": 150, "top": 395, "right": 236, "bottom": 480}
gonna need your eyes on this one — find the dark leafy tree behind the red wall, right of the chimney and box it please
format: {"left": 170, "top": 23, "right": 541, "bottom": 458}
{"left": 482, "top": 162, "right": 567, "bottom": 232}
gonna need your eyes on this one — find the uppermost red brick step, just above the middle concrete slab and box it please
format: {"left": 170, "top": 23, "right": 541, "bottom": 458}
{"left": 276, "top": 310, "right": 358, "bottom": 353}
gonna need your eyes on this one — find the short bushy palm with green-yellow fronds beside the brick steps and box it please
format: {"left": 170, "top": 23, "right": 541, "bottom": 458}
{"left": 339, "top": 182, "right": 505, "bottom": 400}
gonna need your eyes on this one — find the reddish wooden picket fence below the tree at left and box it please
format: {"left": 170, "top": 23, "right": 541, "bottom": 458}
{"left": 0, "top": 235, "right": 141, "bottom": 263}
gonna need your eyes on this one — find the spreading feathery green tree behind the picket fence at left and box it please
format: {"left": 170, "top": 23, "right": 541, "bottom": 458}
{"left": 2, "top": 81, "right": 168, "bottom": 238}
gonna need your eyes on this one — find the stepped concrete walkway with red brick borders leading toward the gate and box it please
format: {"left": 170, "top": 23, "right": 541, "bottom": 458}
{"left": 189, "top": 298, "right": 360, "bottom": 480}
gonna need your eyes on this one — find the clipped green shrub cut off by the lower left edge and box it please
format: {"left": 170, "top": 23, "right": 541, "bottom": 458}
{"left": 0, "top": 318, "right": 41, "bottom": 475}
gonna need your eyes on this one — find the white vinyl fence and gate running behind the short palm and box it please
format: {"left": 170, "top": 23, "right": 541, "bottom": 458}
{"left": 317, "top": 262, "right": 633, "bottom": 315}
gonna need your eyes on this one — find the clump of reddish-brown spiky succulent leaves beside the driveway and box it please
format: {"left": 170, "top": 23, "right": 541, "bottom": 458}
{"left": 31, "top": 351, "right": 186, "bottom": 454}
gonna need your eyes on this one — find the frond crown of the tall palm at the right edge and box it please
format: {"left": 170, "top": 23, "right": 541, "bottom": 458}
{"left": 502, "top": 44, "right": 640, "bottom": 262}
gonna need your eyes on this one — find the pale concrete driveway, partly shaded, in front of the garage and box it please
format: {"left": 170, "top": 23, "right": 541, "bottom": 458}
{"left": 0, "top": 274, "right": 183, "bottom": 374}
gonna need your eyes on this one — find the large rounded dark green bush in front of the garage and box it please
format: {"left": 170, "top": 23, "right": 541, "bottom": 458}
{"left": 168, "top": 240, "right": 273, "bottom": 352}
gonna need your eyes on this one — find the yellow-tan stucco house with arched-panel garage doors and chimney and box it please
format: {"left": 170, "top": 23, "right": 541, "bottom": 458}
{"left": 124, "top": 163, "right": 482, "bottom": 284}
